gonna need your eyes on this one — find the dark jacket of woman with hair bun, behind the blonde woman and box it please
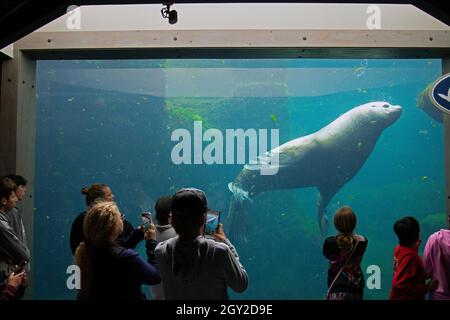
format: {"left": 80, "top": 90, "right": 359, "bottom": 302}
{"left": 70, "top": 211, "right": 144, "bottom": 254}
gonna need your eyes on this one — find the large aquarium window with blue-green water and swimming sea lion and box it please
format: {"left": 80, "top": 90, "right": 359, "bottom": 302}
{"left": 34, "top": 59, "right": 445, "bottom": 299}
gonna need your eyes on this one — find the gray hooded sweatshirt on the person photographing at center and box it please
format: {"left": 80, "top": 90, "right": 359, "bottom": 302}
{"left": 156, "top": 236, "right": 248, "bottom": 300}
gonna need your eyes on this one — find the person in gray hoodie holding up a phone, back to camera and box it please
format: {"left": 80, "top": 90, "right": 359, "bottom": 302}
{"left": 156, "top": 188, "right": 248, "bottom": 300}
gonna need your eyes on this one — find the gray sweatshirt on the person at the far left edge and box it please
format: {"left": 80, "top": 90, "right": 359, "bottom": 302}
{"left": 0, "top": 211, "right": 31, "bottom": 275}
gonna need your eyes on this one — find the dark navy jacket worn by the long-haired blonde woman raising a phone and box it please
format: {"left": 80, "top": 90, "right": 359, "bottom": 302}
{"left": 79, "top": 240, "right": 161, "bottom": 300}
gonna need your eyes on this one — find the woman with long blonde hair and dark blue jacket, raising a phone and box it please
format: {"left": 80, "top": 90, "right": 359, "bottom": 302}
{"left": 75, "top": 202, "right": 161, "bottom": 300}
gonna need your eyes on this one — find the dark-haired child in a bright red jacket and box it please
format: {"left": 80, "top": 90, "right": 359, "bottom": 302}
{"left": 389, "top": 217, "right": 438, "bottom": 300}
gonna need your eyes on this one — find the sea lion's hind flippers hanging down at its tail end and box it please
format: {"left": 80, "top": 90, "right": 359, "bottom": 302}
{"left": 228, "top": 182, "right": 252, "bottom": 242}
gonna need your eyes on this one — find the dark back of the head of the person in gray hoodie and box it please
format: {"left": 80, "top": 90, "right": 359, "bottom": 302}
{"left": 172, "top": 188, "right": 208, "bottom": 237}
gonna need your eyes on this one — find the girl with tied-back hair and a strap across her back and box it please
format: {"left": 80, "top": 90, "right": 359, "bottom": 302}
{"left": 323, "top": 207, "right": 367, "bottom": 300}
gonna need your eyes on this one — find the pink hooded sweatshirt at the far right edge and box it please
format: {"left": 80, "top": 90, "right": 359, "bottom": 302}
{"left": 422, "top": 230, "right": 450, "bottom": 300}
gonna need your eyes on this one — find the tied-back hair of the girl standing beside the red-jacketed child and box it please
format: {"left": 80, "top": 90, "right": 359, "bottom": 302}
{"left": 334, "top": 206, "right": 356, "bottom": 253}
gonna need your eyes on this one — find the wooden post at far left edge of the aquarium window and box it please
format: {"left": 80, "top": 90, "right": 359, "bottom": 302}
{"left": 0, "top": 50, "right": 36, "bottom": 298}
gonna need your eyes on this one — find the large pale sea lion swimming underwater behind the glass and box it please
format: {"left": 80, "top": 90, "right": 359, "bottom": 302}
{"left": 228, "top": 102, "right": 402, "bottom": 238}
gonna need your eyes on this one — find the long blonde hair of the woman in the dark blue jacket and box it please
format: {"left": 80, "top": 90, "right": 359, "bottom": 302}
{"left": 75, "top": 202, "right": 123, "bottom": 299}
